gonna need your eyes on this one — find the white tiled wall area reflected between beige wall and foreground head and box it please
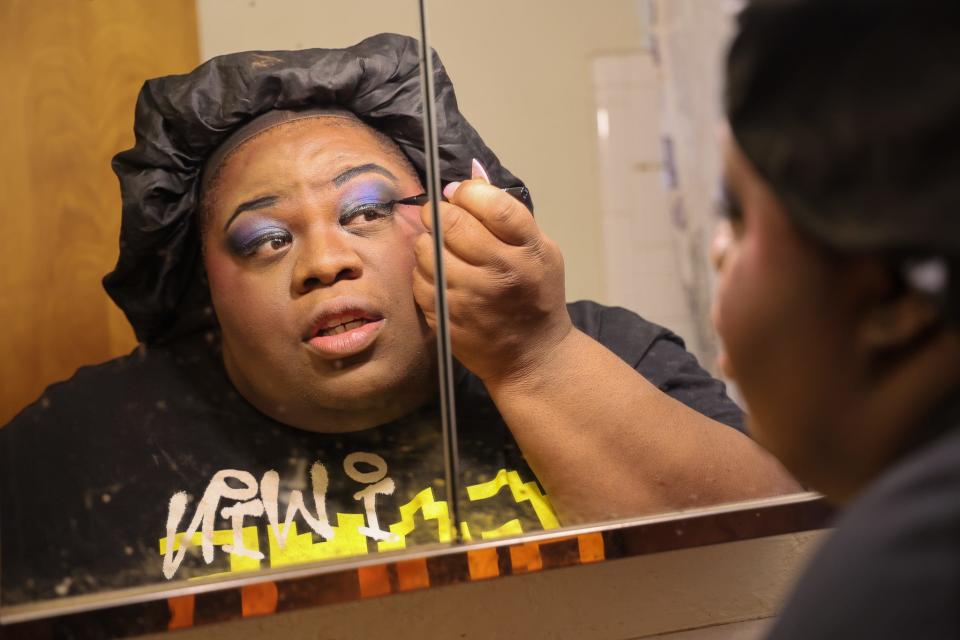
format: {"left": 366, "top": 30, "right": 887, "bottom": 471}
{"left": 592, "top": 0, "right": 733, "bottom": 368}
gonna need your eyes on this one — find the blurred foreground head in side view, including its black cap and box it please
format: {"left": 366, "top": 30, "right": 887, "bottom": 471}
{"left": 714, "top": 0, "right": 960, "bottom": 501}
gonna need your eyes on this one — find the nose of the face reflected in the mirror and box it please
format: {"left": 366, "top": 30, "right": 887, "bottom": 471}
{"left": 293, "top": 227, "right": 363, "bottom": 295}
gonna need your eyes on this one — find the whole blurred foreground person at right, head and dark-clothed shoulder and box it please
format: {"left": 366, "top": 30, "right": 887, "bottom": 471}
{"left": 714, "top": 0, "right": 960, "bottom": 640}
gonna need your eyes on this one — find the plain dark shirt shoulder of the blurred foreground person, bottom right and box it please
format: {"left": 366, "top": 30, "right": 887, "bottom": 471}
{"left": 769, "top": 398, "right": 960, "bottom": 640}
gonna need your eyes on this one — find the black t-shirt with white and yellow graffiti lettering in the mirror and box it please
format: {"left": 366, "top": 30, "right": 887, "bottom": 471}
{"left": 0, "top": 302, "right": 742, "bottom": 605}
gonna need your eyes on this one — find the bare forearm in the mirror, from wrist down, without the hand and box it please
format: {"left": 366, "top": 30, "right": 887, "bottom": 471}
{"left": 485, "top": 329, "right": 799, "bottom": 524}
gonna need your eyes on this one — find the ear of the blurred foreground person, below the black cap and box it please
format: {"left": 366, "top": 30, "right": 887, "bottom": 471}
{"left": 855, "top": 260, "right": 941, "bottom": 354}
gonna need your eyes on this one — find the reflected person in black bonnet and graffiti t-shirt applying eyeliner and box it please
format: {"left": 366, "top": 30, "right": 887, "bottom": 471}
{"left": 0, "top": 35, "right": 795, "bottom": 603}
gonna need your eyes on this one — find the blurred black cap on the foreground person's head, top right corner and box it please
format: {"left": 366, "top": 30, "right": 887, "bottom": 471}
{"left": 727, "top": 0, "right": 960, "bottom": 321}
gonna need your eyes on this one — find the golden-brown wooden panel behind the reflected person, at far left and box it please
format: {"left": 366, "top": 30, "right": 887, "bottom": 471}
{"left": 0, "top": 0, "right": 199, "bottom": 425}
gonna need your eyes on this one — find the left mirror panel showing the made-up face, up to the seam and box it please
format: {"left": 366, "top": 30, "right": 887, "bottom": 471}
{"left": 0, "top": 1, "right": 451, "bottom": 607}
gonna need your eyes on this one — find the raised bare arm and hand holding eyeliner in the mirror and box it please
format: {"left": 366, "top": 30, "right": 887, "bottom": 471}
{"left": 414, "top": 166, "right": 799, "bottom": 524}
